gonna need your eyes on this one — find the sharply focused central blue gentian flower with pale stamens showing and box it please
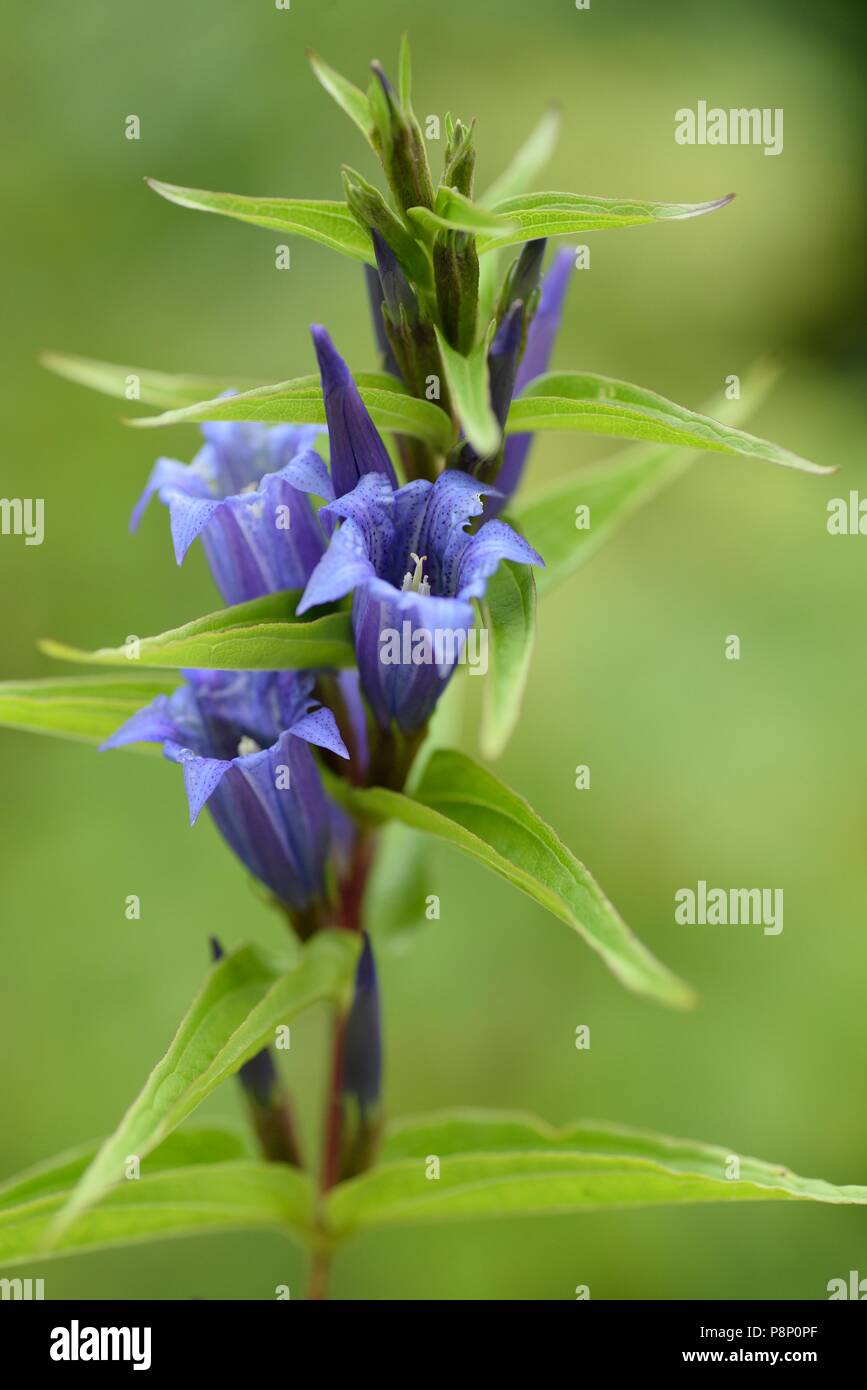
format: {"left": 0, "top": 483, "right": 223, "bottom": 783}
{"left": 293, "top": 329, "right": 543, "bottom": 734}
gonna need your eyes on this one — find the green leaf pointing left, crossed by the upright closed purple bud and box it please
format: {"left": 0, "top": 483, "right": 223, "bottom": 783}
{"left": 129, "top": 373, "right": 454, "bottom": 453}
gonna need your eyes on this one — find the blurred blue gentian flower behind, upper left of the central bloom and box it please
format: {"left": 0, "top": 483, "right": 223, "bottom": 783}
{"left": 129, "top": 421, "right": 327, "bottom": 603}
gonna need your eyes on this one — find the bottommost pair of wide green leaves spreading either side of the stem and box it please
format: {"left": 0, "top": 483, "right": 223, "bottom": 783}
{"left": 0, "top": 1111, "right": 867, "bottom": 1265}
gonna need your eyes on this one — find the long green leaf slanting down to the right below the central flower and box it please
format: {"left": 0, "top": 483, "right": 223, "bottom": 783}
{"left": 328, "top": 749, "right": 693, "bottom": 1008}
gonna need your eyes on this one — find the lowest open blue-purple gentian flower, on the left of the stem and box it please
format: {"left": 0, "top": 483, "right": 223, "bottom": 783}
{"left": 103, "top": 671, "right": 350, "bottom": 934}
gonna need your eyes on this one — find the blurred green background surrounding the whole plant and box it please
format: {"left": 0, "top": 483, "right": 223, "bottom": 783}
{"left": 0, "top": 0, "right": 867, "bottom": 1298}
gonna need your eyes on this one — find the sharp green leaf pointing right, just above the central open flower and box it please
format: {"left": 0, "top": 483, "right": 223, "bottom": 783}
{"left": 506, "top": 371, "right": 835, "bottom": 474}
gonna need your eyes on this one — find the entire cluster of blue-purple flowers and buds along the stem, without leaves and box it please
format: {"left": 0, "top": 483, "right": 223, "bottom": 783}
{"left": 96, "top": 43, "right": 583, "bottom": 1175}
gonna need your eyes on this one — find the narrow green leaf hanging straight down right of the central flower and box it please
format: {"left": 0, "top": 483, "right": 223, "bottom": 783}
{"left": 481, "top": 560, "right": 536, "bottom": 759}
